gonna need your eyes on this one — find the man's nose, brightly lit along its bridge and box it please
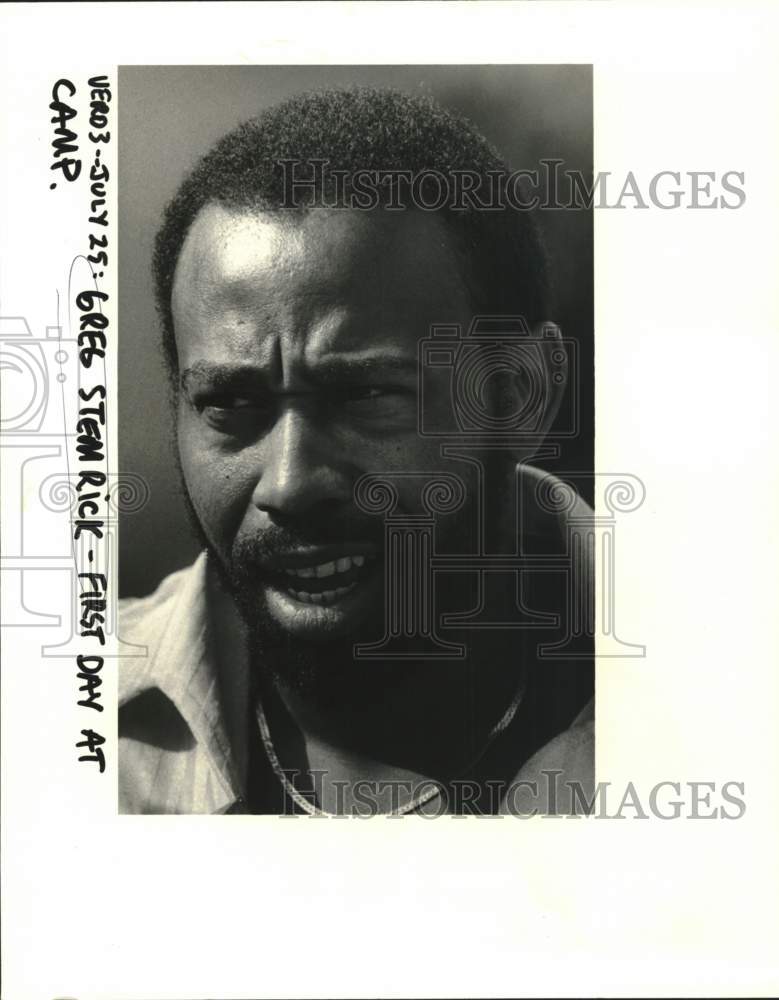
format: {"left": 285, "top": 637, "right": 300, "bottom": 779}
{"left": 252, "top": 405, "right": 351, "bottom": 519}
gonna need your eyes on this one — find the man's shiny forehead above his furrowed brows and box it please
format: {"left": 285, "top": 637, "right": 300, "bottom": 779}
{"left": 172, "top": 205, "right": 467, "bottom": 368}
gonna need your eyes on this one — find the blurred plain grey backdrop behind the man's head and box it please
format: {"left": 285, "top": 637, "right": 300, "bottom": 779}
{"left": 119, "top": 66, "right": 593, "bottom": 596}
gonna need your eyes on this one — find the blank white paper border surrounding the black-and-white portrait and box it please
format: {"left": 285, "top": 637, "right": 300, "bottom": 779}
{"left": 0, "top": 3, "right": 779, "bottom": 1000}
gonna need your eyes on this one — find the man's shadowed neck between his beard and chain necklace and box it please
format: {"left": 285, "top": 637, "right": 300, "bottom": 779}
{"left": 257, "top": 633, "right": 522, "bottom": 780}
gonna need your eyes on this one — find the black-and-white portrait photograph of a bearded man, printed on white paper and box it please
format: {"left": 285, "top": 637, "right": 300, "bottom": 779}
{"left": 119, "top": 66, "right": 595, "bottom": 816}
